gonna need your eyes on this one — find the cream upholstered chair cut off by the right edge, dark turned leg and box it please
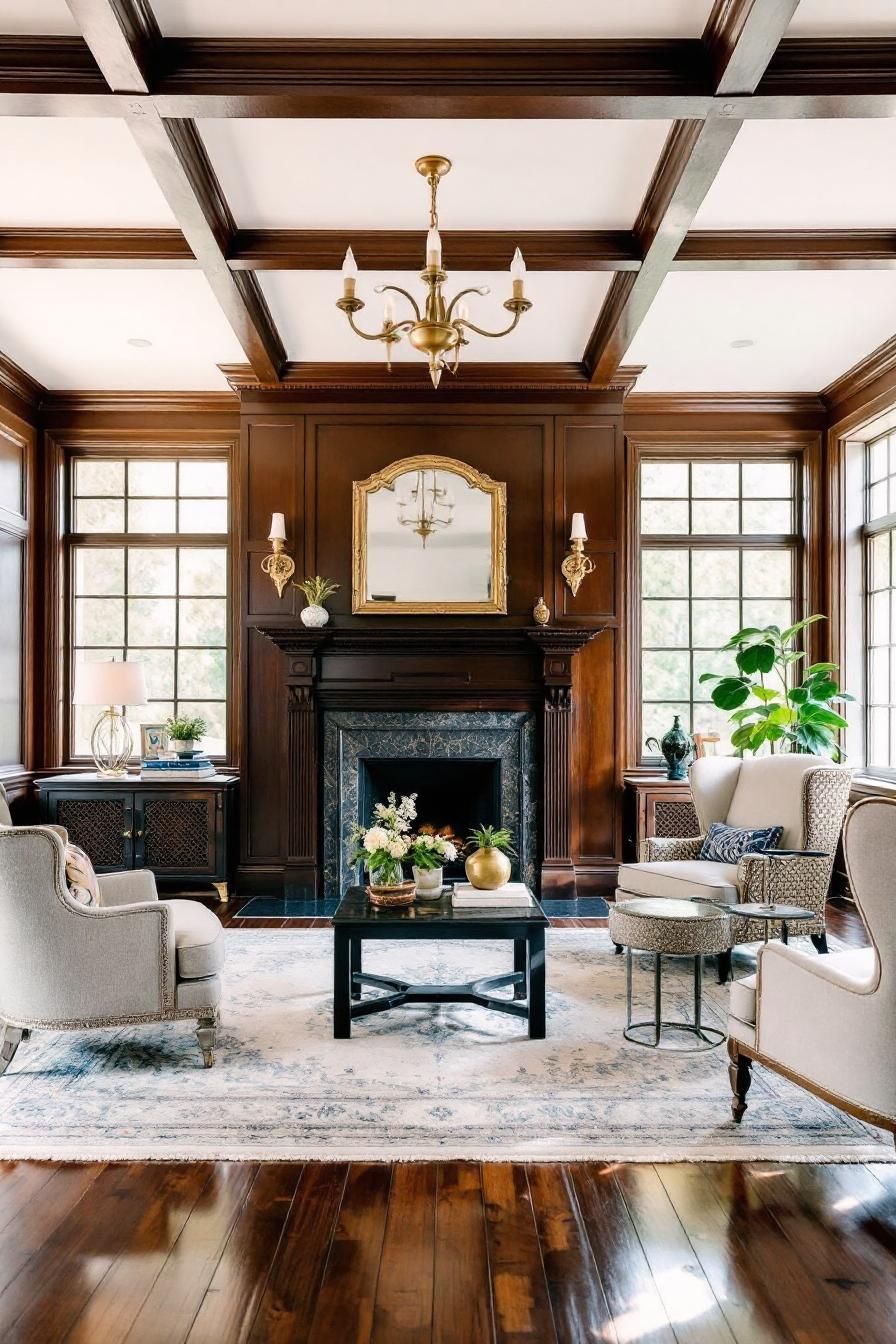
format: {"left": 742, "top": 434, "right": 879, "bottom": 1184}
{"left": 728, "top": 798, "right": 896, "bottom": 1133}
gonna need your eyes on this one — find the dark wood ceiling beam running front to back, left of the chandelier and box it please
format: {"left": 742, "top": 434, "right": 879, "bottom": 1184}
{"left": 61, "top": 0, "right": 286, "bottom": 382}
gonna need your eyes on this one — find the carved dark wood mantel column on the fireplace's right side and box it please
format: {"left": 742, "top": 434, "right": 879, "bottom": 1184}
{"left": 527, "top": 625, "right": 600, "bottom": 895}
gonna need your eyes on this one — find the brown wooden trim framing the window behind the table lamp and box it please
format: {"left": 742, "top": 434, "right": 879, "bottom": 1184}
{"left": 59, "top": 434, "right": 239, "bottom": 770}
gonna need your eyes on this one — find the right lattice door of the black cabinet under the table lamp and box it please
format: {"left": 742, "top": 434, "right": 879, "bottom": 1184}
{"left": 136, "top": 785, "right": 218, "bottom": 876}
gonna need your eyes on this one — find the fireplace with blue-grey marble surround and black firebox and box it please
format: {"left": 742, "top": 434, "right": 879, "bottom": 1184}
{"left": 322, "top": 710, "right": 537, "bottom": 896}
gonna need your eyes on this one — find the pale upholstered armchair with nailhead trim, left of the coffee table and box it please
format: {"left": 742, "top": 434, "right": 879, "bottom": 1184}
{"left": 0, "top": 817, "right": 224, "bottom": 1074}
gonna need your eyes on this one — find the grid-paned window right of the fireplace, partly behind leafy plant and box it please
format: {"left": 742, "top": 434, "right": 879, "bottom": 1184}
{"left": 639, "top": 452, "right": 802, "bottom": 759}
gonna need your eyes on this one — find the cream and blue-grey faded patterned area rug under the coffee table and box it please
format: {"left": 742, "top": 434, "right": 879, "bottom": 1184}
{"left": 0, "top": 929, "right": 893, "bottom": 1161}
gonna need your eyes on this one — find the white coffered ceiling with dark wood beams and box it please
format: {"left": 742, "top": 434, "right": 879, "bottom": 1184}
{"left": 0, "top": 0, "right": 896, "bottom": 391}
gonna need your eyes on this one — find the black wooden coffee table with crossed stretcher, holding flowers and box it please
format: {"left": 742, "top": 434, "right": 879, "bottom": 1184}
{"left": 333, "top": 887, "right": 548, "bottom": 1040}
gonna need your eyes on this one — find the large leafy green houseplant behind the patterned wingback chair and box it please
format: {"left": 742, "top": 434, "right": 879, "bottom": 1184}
{"left": 700, "top": 616, "right": 853, "bottom": 761}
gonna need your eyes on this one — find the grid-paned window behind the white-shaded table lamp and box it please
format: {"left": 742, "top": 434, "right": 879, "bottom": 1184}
{"left": 66, "top": 452, "right": 230, "bottom": 761}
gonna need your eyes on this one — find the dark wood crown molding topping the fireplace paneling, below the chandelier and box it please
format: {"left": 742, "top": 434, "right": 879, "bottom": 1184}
{"left": 218, "top": 362, "right": 642, "bottom": 396}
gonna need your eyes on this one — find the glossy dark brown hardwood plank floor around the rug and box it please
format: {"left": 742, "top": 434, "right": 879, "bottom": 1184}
{"left": 0, "top": 902, "right": 896, "bottom": 1344}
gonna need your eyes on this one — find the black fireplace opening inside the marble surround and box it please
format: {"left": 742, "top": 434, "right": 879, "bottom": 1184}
{"left": 357, "top": 757, "right": 501, "bottom": 882}
